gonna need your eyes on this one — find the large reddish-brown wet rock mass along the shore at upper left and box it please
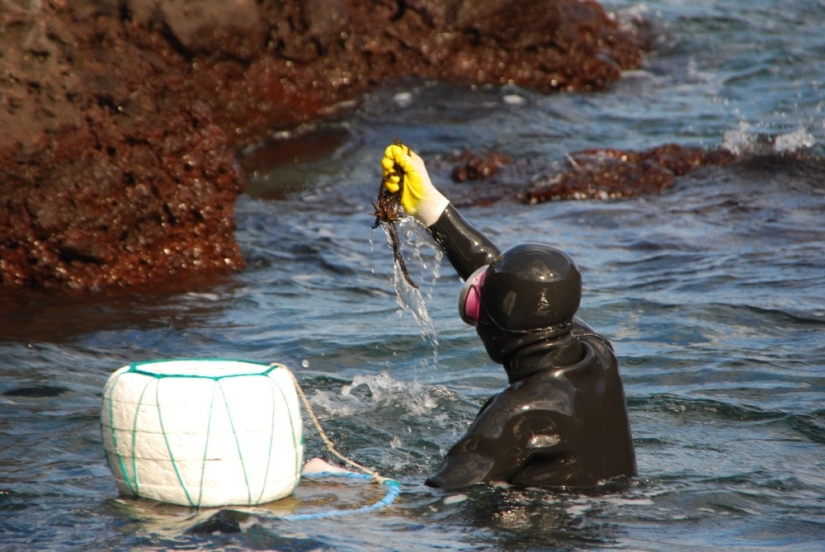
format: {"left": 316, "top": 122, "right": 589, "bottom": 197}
{"left": 0, "top": 0, "right": 643, "bottom": 290}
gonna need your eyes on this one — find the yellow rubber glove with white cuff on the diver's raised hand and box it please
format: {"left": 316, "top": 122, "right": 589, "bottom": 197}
{"left": 381, "top": 143, "right": 450, "bottom": 227}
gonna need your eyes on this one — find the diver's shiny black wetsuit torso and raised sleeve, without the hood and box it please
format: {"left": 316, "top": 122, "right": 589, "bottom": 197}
{"left": 426, "top": 206, "right": 636, "bottom": 489}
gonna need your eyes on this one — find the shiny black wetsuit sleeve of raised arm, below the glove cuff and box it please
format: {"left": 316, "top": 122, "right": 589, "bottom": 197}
{"left": 427, "top": 205, "right": 501, "bottom": 280}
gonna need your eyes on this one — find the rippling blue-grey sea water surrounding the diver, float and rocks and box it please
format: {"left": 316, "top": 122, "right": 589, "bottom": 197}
{"left": 0, "top": 0, "right": 825, "bottom": 551}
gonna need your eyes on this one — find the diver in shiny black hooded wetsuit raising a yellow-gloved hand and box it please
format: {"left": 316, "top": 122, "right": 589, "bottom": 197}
{"left": 382, "top": 144, "right": 636, "bottom": 489}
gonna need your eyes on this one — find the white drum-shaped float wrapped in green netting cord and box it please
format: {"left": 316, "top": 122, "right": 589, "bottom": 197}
{"left": 100, "top": 359, "right": 304, "bottom": 507}
